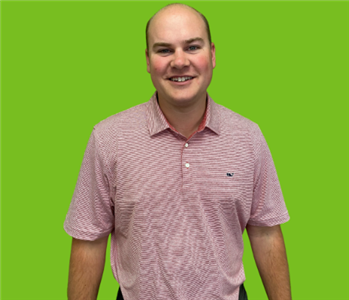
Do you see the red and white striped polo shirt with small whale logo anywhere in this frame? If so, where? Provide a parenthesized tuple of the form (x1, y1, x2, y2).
(64, 93, 289, 300)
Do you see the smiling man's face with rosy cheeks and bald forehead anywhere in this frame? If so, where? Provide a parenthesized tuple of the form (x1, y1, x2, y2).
(146, 7, 216, 106)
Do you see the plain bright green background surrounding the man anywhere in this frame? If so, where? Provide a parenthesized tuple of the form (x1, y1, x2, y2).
(0, 1, 349, 300)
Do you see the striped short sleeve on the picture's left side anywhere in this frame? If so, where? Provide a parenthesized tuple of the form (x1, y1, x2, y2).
(64, 130, 114, 241)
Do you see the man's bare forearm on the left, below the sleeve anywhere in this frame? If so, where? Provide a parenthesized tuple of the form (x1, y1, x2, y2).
(68, 236, 108, 300)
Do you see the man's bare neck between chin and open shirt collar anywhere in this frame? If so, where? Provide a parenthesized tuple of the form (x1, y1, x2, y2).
(158, 94, 206, 138)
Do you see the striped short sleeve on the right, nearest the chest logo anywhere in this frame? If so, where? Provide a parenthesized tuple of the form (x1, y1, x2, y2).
(248, 126, 290, 227)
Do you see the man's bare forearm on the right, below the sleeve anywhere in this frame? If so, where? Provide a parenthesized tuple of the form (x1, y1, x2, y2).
(246, 225, 291, 300)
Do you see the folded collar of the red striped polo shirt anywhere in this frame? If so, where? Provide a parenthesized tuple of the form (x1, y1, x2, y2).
(148, 92, 220, 136)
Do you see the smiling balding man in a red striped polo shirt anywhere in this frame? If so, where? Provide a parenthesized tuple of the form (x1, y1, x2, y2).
(65, 4, 291, 300)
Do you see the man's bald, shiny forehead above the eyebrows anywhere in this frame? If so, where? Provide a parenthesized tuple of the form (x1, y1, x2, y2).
(148, 7, 208, 44)
